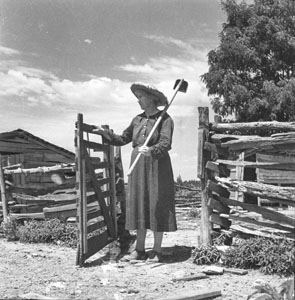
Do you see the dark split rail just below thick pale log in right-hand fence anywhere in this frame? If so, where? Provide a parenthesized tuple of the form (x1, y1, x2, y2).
(212, 195, 295, 227)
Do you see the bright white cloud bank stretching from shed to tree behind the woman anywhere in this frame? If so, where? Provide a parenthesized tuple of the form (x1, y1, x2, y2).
(0, 36, 214, 176)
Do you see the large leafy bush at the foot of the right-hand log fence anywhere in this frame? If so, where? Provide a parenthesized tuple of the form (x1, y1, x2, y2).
(222, 237, 295, 276)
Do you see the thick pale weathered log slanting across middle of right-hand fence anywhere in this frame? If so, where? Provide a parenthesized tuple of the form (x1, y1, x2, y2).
(215, 176, 295, 206)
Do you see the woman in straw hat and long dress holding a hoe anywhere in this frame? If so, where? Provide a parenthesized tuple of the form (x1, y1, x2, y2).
(96, 83, 177, 262)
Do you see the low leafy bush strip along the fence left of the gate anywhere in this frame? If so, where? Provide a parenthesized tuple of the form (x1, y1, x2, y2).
(2, 219, 77, 247)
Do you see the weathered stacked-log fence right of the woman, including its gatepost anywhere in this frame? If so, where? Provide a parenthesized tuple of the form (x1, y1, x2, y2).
(198, 107, 295, 245)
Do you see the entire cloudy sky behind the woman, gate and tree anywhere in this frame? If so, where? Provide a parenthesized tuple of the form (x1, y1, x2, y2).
(0, 0, 226, 180)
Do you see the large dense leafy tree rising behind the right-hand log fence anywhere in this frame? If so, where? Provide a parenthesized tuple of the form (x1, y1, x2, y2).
(201, 0, 295, 122)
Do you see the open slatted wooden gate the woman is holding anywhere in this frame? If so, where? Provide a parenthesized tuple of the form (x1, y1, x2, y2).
(75, 114, 117, 266)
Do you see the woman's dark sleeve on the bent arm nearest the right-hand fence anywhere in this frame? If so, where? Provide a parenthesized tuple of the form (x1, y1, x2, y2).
(151, 117, 174, 159)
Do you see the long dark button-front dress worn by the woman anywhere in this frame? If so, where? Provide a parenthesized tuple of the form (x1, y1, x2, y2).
(104, 112, 177, 232)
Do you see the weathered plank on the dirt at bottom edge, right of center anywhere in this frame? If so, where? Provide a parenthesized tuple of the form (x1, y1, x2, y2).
(158, 288, 221, 300)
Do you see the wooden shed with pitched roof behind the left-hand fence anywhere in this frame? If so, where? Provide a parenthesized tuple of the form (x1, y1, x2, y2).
(0, 129, 75, 192)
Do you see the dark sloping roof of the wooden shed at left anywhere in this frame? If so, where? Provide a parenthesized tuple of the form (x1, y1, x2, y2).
(0, 129, 75, 159)
